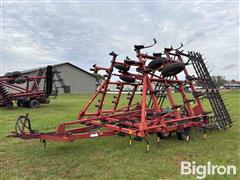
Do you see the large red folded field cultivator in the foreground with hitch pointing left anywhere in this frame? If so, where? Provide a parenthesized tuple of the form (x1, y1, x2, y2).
(12, 40, 232, 149)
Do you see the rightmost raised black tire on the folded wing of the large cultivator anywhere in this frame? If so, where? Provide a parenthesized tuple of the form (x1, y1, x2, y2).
(162, 62, 185, 77)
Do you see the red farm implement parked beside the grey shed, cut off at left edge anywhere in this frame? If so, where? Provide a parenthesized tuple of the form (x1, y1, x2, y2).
(0, 66, 52, 108)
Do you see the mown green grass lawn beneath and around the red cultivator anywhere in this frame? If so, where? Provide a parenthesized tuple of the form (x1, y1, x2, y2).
(0, 91, 240, 179)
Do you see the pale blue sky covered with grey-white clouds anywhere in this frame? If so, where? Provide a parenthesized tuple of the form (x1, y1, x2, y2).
(1, 0, 239, 79)
